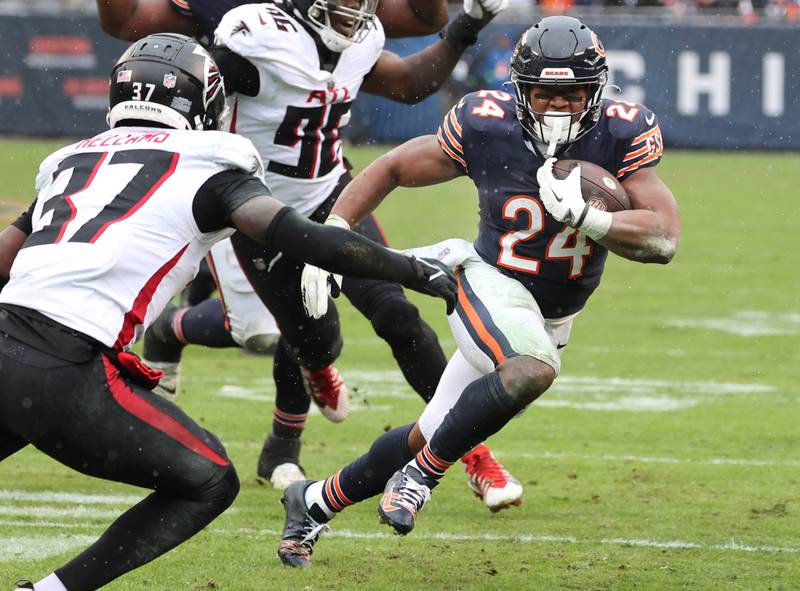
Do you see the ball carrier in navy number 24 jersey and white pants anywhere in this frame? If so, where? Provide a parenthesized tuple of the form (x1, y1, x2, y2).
(278, 16, 680, 566)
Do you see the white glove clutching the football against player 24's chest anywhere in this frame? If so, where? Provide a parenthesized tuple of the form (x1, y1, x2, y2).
(536, 158, 612, 240)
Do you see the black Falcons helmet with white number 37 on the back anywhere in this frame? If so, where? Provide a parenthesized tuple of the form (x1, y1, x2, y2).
(108, 33, 227, 130)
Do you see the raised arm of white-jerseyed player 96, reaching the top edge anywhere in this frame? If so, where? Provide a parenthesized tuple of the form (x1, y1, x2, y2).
(361, 0, 508, 105)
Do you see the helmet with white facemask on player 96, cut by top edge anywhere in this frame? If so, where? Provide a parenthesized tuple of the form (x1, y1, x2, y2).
(284, 0, 378, 53)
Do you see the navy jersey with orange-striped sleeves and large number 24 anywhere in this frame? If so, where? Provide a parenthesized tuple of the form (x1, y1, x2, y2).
(437, 90, 664, 318)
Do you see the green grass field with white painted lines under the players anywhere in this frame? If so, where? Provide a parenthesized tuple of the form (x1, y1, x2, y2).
(0, 141, 800, 591)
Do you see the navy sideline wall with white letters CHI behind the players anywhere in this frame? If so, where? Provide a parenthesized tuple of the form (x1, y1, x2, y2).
(0, 15, 800, 150)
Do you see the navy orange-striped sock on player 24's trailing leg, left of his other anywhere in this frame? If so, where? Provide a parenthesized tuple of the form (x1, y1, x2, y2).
(322, 423, 414, 513)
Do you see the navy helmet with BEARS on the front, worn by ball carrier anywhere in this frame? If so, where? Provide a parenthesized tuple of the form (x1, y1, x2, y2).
(510, 16, 608, 146)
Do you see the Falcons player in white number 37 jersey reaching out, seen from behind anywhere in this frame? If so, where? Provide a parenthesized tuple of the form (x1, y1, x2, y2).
(0, 34, 455, 591)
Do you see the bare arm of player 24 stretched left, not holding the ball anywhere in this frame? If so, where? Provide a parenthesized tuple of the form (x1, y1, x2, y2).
(331, 135, 463, 228)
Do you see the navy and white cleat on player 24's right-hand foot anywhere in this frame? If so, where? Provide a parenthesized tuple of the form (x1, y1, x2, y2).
(378, 465, 439, 536)
